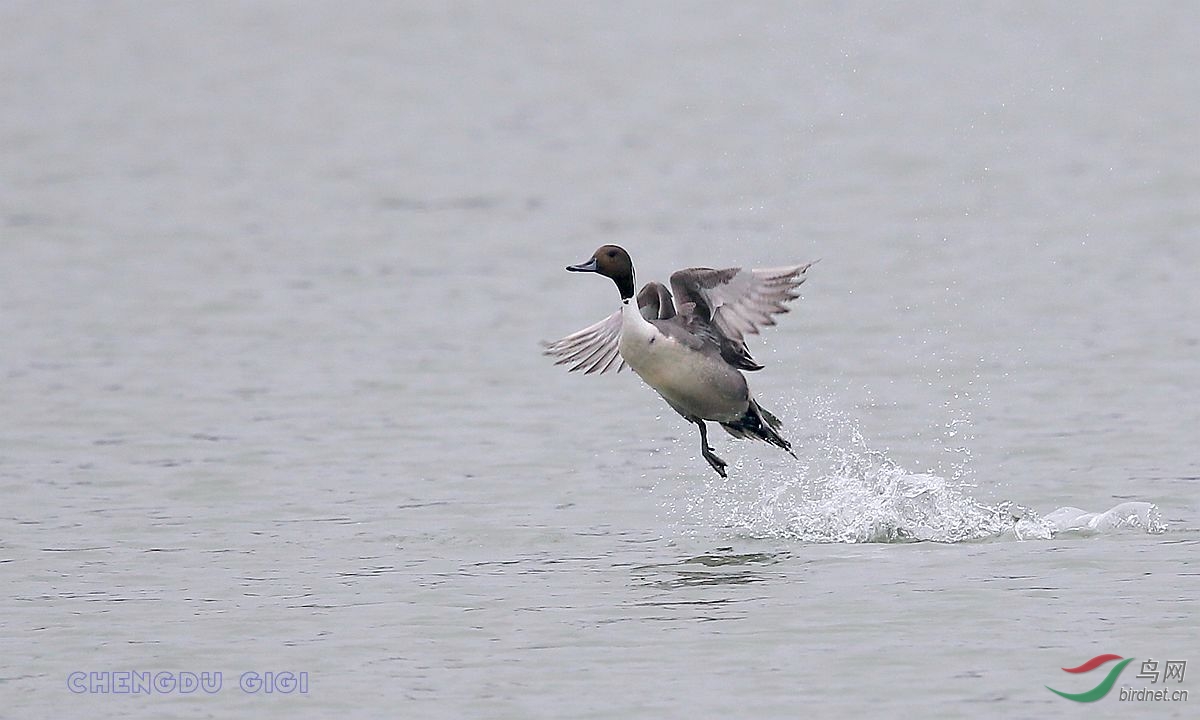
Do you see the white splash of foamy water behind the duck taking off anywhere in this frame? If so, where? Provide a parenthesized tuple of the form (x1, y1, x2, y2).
(665, 397, 1166, 542)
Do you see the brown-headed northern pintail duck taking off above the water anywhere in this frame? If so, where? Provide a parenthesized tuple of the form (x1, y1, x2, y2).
(546, 245, 812, 478)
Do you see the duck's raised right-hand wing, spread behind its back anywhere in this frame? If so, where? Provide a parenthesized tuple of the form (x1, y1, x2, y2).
(671, 263, 812, 343)
